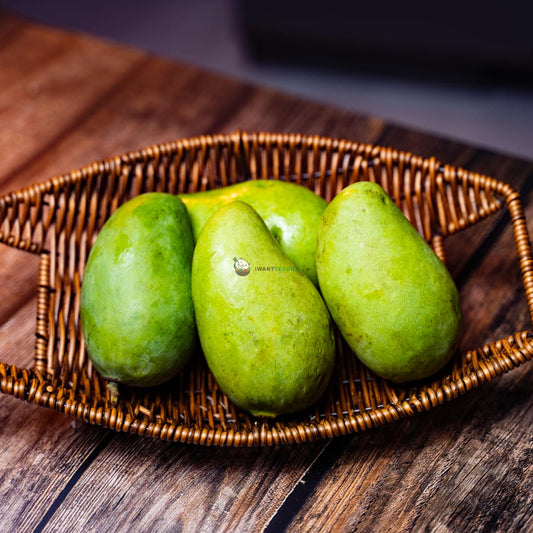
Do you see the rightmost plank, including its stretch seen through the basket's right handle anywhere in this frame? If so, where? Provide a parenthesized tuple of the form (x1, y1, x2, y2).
(276, 156, 533, 531)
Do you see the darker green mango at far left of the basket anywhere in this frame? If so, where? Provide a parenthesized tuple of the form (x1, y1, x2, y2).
(81, 193, 196, 386)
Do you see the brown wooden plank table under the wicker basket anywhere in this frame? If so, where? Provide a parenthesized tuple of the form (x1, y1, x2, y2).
(0, 15, 533, 532)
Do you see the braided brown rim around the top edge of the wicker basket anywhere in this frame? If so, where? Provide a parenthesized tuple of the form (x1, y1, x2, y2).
(0, 130, 533, 446)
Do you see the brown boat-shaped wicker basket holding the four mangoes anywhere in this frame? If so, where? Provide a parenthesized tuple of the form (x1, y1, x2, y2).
(0, 132, 533, 446)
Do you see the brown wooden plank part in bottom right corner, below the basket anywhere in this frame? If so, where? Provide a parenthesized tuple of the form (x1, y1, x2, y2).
(288, 365, 533, 532)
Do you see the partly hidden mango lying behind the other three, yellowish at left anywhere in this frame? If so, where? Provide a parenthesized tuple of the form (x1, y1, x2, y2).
(179, 180, 327, 285)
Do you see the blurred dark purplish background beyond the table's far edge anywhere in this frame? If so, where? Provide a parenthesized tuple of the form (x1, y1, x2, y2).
(0, 0, 533, 159)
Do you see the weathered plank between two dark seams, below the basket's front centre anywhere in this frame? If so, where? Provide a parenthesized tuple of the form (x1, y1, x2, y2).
(38, 435, 323, 533)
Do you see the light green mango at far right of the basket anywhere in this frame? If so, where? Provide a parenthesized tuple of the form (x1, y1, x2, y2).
(317, 182, 461, 383)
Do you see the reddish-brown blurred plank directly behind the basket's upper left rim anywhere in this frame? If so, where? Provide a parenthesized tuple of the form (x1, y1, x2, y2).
(0, 59, 247, 195)
